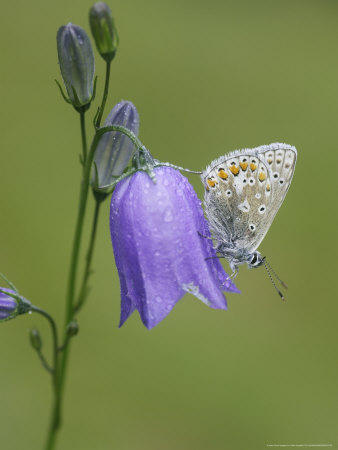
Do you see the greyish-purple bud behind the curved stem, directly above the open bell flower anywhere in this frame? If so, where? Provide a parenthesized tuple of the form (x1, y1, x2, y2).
(94, 100, 139, 188)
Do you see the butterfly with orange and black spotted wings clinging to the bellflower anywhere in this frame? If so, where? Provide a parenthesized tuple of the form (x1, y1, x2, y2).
(201, 143, 297, 298)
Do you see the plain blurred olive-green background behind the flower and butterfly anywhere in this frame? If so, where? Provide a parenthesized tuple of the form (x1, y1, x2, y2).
(0, 0, 338, 450)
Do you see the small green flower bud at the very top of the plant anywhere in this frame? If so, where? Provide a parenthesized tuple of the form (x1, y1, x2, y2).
(89, 2, 118, 62)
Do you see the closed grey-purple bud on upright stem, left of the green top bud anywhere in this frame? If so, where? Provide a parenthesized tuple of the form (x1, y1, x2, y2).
(56, 23, 95, 109)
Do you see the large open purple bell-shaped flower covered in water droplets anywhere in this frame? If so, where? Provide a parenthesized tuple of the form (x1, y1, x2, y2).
(110, 167, 239, 329)
